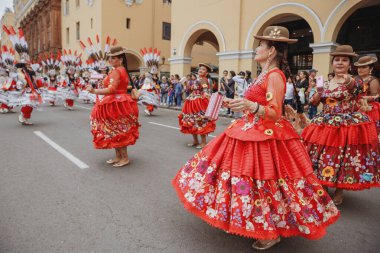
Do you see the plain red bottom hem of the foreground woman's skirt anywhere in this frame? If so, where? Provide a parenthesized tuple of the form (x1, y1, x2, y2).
(172, 178, 340, 240)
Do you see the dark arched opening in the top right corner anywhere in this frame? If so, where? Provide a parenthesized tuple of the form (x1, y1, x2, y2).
(336, 1, 380, 77)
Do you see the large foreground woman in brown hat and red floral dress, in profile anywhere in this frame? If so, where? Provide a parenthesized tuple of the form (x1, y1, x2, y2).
(173, 26, 339, 250)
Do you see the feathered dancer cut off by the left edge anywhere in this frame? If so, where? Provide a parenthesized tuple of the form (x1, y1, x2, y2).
(0, 45, 19, 113)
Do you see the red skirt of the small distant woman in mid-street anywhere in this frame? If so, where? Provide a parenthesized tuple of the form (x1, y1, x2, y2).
(178, 95, 216, 135)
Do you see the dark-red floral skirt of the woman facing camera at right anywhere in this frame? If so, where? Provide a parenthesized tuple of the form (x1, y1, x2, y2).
(302, 112, 380, 190)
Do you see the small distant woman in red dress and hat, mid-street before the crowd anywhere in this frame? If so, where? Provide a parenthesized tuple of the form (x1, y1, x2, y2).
(178, 63, 216, 148)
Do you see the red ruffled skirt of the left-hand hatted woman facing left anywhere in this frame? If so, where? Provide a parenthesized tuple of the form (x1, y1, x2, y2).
(91, 94, 140, 149)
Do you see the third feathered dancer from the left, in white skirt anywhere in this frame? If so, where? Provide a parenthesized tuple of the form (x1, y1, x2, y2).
(41, 52, 62, 106)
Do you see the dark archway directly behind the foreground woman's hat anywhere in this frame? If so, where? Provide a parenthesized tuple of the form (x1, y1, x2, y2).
(253, 14, 314, 74)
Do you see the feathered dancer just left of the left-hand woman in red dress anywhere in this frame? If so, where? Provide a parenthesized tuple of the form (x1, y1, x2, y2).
(59, 50, 82, 111)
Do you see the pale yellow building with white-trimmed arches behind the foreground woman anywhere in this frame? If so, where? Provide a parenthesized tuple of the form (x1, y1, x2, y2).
(169, 0, 380, 77)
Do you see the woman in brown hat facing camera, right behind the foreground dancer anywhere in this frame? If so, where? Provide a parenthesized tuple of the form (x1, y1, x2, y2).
(302, 45, 380, 205)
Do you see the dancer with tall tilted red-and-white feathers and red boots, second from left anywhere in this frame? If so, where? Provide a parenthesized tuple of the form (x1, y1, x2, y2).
(3, 25, 43, 125)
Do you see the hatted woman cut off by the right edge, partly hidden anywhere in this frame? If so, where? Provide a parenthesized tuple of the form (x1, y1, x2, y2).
(354, 55, 380, 140)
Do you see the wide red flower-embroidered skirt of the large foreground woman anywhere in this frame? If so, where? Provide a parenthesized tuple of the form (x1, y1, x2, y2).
(172, 118, 339, 239)
